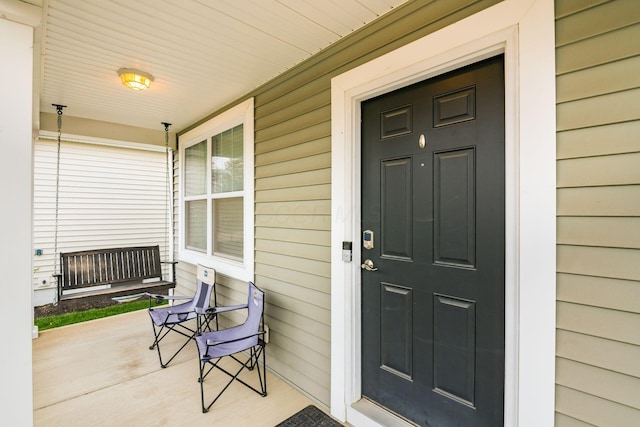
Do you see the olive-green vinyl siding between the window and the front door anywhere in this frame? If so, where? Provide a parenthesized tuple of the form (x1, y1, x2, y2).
(179, 0, 499, 406)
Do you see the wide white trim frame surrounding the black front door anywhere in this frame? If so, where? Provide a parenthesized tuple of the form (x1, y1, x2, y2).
(331, 0, 556, 427)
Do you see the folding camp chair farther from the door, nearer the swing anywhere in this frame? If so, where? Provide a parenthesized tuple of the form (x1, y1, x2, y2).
(146, 265, 217, 368)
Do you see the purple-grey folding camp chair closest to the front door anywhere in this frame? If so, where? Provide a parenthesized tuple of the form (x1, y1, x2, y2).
(196, 282, 267, 412)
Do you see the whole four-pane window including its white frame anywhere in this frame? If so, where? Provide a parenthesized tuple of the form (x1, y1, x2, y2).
(180, 99, 253, 280)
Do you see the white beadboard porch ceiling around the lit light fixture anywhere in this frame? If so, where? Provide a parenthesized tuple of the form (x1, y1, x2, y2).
(32, 0, 406, 132)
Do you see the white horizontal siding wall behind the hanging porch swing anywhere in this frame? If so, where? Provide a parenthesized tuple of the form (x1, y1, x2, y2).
(33, 140, 169, 302)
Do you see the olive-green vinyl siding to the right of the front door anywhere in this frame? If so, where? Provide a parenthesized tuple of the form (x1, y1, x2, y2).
(556, 0, 640, 427)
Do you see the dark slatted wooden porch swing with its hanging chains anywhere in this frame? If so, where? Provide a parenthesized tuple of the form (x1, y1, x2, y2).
(52, 104, 176, 307)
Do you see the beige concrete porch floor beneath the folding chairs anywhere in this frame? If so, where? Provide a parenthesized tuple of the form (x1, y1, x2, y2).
(33, 310, 315, 427)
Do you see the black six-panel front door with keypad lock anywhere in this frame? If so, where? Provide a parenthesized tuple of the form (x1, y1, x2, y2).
(361, 56, 505, 427)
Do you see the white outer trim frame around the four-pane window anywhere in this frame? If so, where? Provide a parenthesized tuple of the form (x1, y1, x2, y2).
(178, 98, 254, 281)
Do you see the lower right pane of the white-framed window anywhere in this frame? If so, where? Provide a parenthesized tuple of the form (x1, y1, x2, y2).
(213, 197, 244, 260)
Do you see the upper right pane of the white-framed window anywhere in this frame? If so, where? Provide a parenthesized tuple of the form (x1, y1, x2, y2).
(211, 125, 244, 193)
